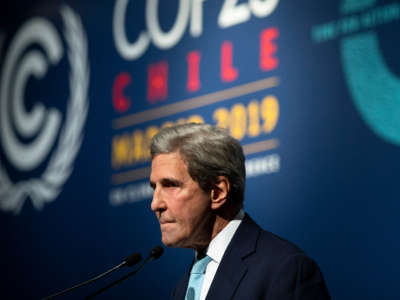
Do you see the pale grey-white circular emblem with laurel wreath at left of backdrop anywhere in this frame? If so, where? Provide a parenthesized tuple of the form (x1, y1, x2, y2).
(0, 6, 89, 214)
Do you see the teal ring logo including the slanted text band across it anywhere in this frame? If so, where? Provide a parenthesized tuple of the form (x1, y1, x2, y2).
(312, 0, 400, 145)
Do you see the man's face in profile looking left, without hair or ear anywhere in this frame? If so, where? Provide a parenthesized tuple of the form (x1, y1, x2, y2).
(150, 152, 212, 249)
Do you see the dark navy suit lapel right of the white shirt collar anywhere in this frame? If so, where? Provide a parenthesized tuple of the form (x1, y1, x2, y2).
(206, 214, 261, 300)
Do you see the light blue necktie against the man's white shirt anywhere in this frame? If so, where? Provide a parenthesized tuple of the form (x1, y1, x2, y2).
(185, 256, 211, 300)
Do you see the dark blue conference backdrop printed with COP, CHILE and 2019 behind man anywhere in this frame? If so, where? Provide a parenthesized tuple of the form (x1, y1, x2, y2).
(0, 0, 400, 299)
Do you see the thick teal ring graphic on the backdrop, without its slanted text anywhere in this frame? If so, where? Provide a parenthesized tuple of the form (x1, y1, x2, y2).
(341, 0, 400, 145)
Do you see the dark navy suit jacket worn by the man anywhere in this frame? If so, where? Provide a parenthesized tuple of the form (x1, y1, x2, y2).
(172, 214, 330, 300)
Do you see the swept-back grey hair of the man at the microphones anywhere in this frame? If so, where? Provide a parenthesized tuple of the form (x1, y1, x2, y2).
(150, 123, 246, 206)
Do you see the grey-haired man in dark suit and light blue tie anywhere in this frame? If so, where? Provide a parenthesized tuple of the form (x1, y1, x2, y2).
(150, 124, 330, 300)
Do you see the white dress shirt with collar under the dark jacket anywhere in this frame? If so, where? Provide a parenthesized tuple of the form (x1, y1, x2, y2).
(196, 209, 244, 300)
